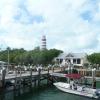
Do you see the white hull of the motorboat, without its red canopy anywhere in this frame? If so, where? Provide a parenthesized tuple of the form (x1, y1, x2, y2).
(54, 82, 100, 98)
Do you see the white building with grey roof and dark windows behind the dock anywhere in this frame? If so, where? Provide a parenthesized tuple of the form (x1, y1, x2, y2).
(55, 53, 88, 66)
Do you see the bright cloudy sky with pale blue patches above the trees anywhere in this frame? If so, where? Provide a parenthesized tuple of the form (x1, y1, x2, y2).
(0, 0, 100, 53)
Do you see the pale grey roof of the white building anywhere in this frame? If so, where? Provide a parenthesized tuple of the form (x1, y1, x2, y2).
(57, 53, 87, 58)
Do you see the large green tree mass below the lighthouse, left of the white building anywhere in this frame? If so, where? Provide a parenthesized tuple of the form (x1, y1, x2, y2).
(0, 47, 63, 65)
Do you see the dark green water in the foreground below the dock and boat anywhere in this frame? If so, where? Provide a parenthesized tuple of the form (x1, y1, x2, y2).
(0, 81, 100, 100)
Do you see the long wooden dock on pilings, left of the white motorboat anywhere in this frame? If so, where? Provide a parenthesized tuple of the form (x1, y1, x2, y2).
(0, 68, 61, 89)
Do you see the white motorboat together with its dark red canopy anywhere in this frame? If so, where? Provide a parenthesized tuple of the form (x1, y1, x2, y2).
(54, 74, 100, 99)
